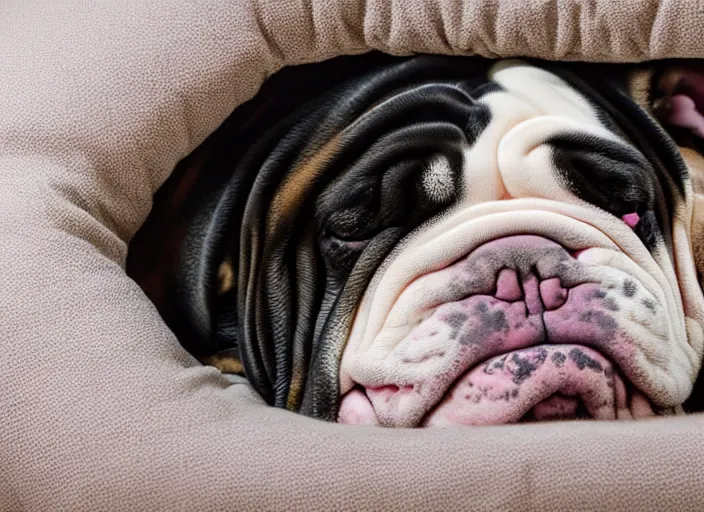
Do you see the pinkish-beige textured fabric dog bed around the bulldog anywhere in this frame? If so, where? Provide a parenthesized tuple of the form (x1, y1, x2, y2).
(0, 0, 704, 510)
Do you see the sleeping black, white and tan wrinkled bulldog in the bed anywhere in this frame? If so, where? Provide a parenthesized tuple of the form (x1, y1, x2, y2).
(128, 54, 704, 427)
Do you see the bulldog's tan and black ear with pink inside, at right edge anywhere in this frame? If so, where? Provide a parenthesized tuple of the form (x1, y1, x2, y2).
(629, 60, 704, 286)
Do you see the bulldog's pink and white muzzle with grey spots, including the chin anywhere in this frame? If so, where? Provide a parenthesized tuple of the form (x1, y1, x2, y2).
(340, 235, 666, 426)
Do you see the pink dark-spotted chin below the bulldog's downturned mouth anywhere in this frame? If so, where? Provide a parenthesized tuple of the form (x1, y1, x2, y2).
(424, 345, 654, 427)
